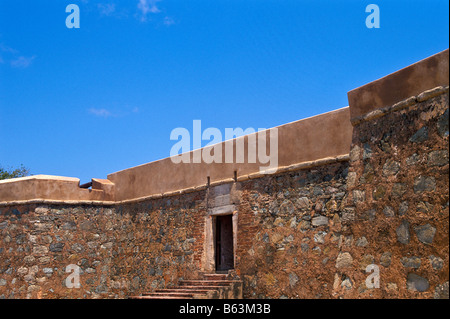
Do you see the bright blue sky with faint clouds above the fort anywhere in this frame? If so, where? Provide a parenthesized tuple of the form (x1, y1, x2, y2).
(0, 0, 449, 183)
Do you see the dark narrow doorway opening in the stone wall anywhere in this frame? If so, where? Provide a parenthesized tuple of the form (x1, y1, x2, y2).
(215, 215, 234, 271)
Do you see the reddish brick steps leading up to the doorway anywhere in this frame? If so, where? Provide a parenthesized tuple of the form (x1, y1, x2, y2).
(129, 273, 242, 299)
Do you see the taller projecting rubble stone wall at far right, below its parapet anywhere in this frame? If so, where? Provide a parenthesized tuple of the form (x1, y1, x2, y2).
(335, 87, 449, 298)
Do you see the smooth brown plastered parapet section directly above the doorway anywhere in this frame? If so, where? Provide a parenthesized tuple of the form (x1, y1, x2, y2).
(108, 107, 352, 201)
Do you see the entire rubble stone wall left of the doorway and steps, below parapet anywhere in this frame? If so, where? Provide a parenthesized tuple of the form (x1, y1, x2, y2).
(0, 192, 205, 298)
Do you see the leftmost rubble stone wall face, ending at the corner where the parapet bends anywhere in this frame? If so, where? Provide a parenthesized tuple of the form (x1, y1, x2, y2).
(0, 205, 121, 298)
